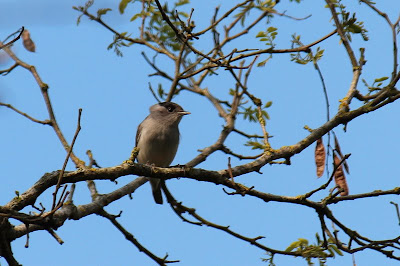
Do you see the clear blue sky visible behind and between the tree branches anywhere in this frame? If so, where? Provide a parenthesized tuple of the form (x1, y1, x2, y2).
(0, 0, 400, 266)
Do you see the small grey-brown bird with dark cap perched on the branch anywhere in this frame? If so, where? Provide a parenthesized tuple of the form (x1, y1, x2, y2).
(136, 102, 190, 204)
